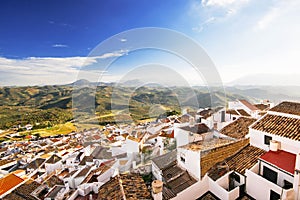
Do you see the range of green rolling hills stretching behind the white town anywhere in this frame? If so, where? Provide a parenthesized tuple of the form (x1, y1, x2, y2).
(0, 80, 300, 129)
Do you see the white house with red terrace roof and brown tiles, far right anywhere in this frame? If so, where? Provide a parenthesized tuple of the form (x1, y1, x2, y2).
(246, 102, 300, 200)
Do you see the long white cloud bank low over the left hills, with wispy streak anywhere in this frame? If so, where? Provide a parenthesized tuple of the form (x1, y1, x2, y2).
(0, 50, 127, 85)
